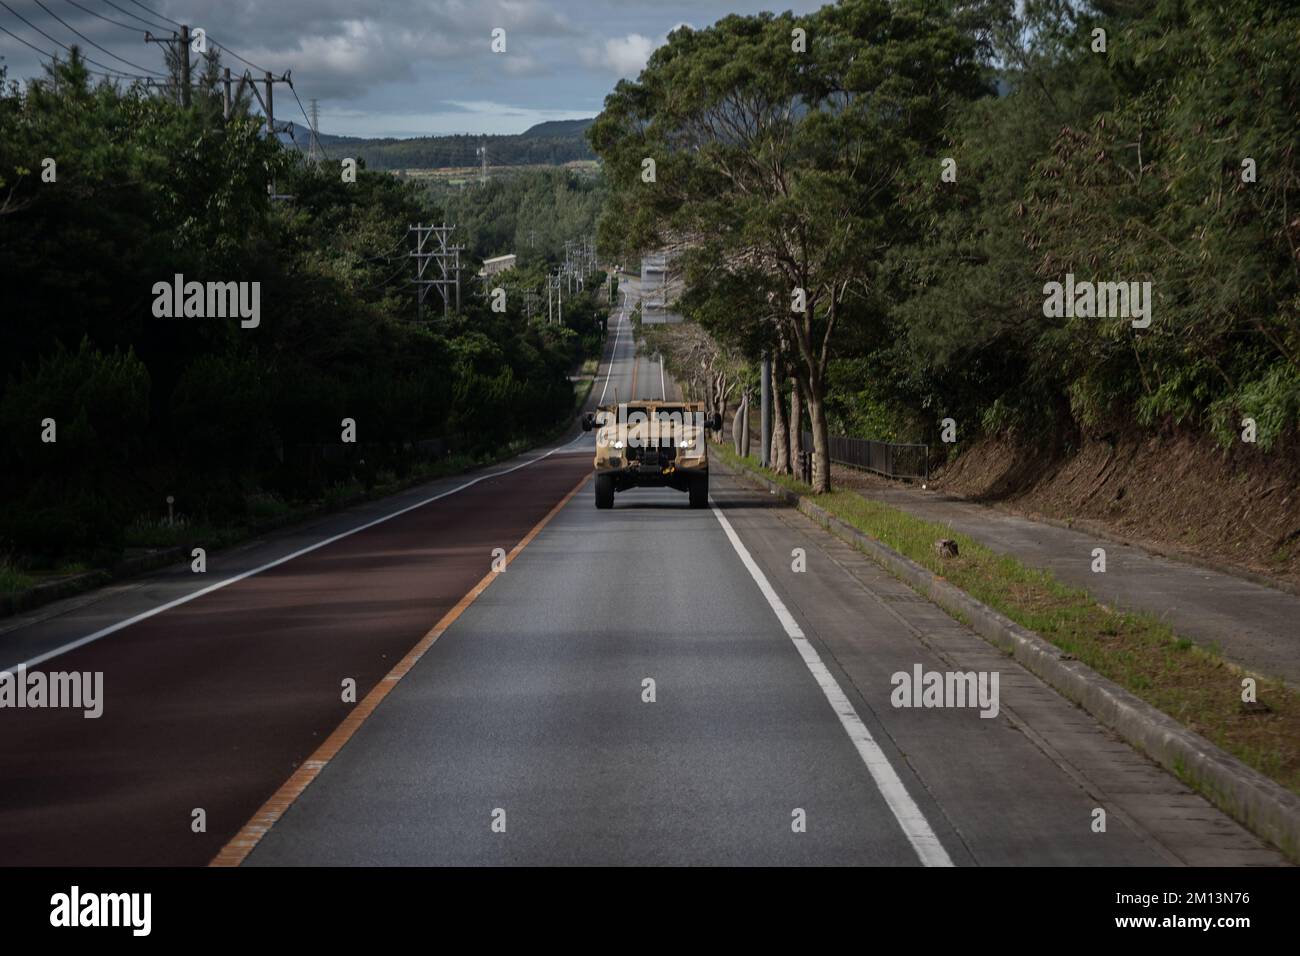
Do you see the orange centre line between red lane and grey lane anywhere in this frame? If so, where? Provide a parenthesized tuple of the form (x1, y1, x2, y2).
(208, 475, 592, 866)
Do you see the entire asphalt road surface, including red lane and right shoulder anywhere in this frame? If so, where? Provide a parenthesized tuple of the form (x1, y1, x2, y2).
(0, 300, 1282, 866)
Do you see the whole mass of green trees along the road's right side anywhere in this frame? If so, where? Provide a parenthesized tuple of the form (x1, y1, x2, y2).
(590, 0, 1300, 489)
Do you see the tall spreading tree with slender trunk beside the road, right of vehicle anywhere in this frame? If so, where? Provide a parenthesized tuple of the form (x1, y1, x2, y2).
(590, 0, 988, 492)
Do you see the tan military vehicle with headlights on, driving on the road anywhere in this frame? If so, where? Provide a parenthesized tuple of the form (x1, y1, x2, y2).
(582, 402, 723, 509)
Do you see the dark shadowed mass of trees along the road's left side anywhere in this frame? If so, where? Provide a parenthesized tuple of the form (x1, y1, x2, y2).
(0, 53, 605, 567)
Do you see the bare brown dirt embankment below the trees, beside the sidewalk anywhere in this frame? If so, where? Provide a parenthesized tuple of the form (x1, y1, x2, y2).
(878, 434, 1300, 587)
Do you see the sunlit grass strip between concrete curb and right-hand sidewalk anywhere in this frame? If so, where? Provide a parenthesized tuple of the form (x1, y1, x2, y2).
(712, 445, 1300, 793)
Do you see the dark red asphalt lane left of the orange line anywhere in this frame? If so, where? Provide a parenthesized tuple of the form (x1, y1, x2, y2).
(0, 454, 592, 866)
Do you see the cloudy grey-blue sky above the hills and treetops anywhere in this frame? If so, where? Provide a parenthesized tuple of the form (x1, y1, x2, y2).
(0, 0, 824, 137)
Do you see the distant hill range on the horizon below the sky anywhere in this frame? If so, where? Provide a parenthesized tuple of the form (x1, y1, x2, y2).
(281, 120, 595, 169)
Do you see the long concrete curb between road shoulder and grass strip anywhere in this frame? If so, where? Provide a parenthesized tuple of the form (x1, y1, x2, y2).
(724, 452, 1300, 862)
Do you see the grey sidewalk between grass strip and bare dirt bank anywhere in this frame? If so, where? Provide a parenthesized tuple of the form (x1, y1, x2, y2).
(854, 485, 1300, 685)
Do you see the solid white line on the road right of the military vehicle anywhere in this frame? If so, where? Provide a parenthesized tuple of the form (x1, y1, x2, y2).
(710, 503, 953, 866)
